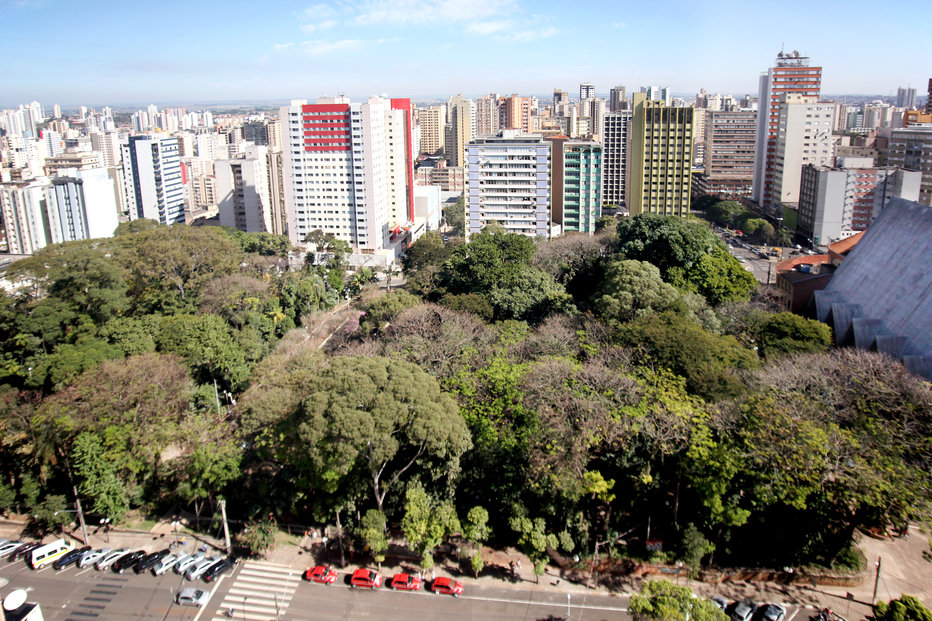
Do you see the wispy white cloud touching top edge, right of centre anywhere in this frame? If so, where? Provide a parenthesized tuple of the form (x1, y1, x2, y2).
(350, 0, 515, 26)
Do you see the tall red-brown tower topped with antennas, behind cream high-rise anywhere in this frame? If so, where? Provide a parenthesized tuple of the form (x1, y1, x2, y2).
(752, 51, 822, 207)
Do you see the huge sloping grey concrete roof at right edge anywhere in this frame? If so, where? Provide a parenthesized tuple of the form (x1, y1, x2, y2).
(822, 198, 932, 366)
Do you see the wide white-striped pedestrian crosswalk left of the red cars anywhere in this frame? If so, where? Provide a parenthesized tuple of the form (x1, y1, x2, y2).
(214, 561, 301, 621)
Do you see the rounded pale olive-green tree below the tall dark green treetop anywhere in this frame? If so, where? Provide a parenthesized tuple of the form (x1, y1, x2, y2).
(593, 260, 679, 323)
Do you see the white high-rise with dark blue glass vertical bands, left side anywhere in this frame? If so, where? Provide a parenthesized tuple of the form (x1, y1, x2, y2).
(121, 136, 185, 224)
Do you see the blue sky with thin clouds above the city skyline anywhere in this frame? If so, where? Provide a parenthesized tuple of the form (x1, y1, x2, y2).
(0, 0, 932, 107)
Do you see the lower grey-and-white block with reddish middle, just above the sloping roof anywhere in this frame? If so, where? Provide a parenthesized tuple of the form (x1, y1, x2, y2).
(796, 158, 920, 245)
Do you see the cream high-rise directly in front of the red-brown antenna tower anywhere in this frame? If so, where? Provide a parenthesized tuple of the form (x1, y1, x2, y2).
(771, 93, 835, 205)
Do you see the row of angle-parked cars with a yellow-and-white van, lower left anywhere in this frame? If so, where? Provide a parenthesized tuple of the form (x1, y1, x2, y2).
(0, 539, 234, 582)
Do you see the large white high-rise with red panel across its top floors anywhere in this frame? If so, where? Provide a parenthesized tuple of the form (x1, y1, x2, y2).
(280, 97, 414, 254)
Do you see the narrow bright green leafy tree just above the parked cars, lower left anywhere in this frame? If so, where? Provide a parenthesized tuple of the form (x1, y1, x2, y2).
(71, 432, 129, 524)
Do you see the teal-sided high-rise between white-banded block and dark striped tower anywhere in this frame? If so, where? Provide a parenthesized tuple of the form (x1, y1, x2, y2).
(546, 136, 602, 234)
